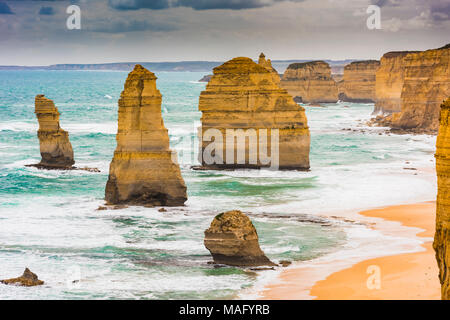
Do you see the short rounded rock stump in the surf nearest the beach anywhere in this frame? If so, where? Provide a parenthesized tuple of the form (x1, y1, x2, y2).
(204, 210, 276, 267)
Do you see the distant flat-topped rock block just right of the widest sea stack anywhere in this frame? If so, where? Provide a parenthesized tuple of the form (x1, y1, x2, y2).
(280, 61, 338, 103)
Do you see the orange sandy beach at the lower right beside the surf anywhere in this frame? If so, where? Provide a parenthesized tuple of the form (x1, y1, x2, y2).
(261, 202, 440, 300)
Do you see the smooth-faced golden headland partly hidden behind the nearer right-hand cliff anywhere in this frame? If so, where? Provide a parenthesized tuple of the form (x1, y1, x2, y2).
(373, 51, 418, 114)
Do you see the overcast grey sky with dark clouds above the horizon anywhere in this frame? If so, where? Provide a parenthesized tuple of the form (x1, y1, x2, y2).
(0, 0, 450, 65)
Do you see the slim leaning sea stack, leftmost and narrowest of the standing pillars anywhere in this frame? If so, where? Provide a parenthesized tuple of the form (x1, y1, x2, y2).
(35, 94, 75, 169)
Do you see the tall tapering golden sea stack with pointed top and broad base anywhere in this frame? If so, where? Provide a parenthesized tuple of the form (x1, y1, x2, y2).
(105, 65, 187, 206)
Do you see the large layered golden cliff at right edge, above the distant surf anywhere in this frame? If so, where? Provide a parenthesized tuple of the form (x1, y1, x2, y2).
(393, 44, 450, 133)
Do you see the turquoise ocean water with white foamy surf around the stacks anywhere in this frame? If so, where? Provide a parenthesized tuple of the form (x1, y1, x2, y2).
(0, 71, 435, 299)
